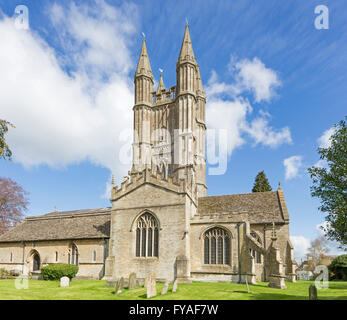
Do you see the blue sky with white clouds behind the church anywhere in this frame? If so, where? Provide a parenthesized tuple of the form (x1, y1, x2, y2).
(0, 0, 347, 257)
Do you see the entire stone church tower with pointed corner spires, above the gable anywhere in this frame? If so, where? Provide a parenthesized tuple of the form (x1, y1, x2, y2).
(131, 25, 207, 197)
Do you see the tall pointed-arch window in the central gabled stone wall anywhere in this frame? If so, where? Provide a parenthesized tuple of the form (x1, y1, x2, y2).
(136, 213, 159, 257)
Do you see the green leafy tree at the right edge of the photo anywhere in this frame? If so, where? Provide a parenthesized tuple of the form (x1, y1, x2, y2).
(308, 117, 347, 250)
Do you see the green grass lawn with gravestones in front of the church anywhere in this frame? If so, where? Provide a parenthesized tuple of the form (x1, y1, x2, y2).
(0, 280, 347, 300)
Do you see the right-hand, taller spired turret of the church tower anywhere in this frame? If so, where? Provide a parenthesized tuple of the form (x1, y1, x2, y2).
(175, 24, 207, 197)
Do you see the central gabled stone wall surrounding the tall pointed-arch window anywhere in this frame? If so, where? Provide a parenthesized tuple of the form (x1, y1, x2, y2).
(106, 183, 196, 281)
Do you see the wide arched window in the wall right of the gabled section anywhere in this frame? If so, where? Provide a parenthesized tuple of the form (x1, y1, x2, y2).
(204, 228, 231, 265)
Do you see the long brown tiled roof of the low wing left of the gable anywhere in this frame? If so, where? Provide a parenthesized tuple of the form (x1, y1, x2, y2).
(0, 208, 111, 242)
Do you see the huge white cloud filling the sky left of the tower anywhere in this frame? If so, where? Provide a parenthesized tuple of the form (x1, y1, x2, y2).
(0, 1, 136, 177)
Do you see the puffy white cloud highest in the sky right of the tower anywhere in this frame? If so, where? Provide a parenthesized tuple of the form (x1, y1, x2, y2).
(235, 57, 281, 102)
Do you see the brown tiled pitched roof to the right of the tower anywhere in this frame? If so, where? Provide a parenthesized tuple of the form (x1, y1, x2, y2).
(198, 191, 289, 223)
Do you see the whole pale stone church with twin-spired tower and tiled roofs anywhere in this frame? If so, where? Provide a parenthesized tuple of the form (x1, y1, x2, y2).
(0, 25, 296, 288)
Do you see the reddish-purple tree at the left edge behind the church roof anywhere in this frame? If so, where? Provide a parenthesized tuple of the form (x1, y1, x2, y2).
(0, 177, 29, 234)
